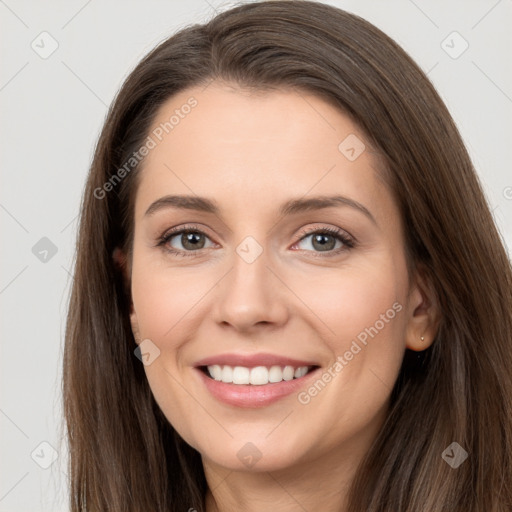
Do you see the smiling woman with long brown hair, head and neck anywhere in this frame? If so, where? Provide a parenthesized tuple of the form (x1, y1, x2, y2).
(63, 1, 512, 512)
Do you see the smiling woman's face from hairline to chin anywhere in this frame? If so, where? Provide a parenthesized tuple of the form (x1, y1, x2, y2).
(126, 82, 427, 471)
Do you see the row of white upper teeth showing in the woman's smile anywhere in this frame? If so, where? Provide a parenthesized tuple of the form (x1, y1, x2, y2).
(207, 364, 308, 386)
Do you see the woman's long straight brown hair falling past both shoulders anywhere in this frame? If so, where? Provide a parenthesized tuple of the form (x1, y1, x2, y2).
(63, 1, 512, 512)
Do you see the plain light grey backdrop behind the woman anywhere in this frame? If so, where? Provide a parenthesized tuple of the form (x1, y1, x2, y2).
(0, 0, 512, 512)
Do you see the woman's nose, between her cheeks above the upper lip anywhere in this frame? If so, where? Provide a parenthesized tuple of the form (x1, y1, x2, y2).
(215, 242, 289, 333)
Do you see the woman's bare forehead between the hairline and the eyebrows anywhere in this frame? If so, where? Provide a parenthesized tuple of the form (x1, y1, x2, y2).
(136, 82, 391, 221)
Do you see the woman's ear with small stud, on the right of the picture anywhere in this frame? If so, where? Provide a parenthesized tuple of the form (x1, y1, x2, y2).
(405, 268, 441, 351)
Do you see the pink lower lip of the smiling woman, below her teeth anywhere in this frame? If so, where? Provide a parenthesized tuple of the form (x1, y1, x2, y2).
(195, 368, 318, 408)
